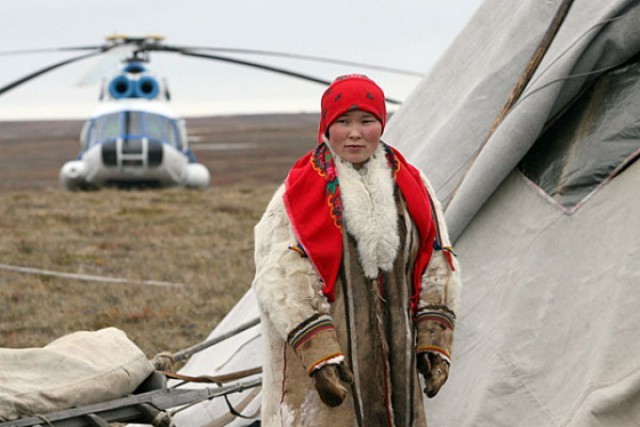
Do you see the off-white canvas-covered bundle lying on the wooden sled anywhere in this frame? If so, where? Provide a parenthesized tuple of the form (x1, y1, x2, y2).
(0, 328, 153, 420)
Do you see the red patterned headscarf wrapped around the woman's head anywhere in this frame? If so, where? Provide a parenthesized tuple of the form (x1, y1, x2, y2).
(318, 74, 387, 142)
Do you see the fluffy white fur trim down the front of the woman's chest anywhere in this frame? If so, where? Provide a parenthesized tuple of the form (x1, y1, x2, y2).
(334, 144, 400, 278)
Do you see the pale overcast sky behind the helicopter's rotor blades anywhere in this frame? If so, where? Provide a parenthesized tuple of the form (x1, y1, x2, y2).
(0, 0, 482, 120)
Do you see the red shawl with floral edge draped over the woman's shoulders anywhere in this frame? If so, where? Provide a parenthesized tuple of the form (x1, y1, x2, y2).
(283, 142, 436, 308)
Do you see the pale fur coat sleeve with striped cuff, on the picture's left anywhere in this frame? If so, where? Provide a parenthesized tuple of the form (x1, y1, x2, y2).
(253, 186, 344, 375)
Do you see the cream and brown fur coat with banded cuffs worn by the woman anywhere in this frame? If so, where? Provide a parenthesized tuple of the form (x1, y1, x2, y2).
(253, 148, 461, 427)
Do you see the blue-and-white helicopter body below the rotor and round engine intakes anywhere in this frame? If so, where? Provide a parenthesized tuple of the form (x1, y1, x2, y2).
(60, 63, 210, 190)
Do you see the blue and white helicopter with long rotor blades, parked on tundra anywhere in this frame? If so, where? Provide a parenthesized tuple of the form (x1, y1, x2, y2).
(0, 34, 422, 190)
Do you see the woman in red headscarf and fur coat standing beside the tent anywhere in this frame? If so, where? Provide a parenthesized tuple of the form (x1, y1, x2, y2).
(253, 75, 461, 426)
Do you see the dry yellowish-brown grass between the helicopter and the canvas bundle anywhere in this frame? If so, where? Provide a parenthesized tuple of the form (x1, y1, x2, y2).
(0, 184, 276, 357)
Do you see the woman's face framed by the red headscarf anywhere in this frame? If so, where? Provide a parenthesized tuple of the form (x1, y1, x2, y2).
(329, 110, 382, 169)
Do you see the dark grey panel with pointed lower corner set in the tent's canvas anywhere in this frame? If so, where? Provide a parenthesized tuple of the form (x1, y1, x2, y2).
(520, 58, 640, 209)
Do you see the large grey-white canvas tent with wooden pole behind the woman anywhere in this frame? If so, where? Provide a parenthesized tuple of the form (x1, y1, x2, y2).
(176, 0, 640, 427)
